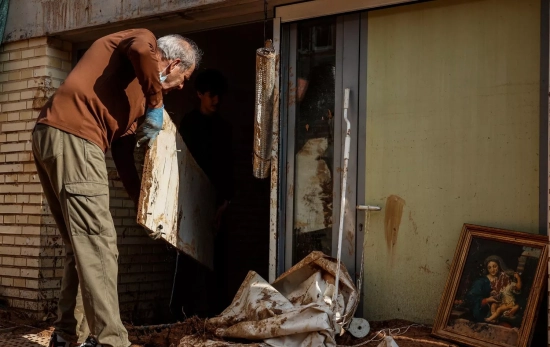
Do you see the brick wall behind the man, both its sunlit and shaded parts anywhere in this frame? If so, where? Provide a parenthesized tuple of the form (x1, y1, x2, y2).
(0, 37, 174, 321)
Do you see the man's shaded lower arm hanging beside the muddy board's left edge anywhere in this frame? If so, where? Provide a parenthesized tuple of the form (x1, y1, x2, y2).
(111, 123, 141, 209)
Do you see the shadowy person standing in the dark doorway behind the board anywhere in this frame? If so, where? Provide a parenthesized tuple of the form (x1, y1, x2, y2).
(174, 69, 234, 319)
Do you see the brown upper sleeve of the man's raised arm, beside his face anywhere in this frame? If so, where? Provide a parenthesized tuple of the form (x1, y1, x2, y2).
(118, 29, 162, 107)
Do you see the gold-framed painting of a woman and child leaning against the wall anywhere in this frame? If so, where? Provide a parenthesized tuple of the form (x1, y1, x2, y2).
(432, 224, 548, 347)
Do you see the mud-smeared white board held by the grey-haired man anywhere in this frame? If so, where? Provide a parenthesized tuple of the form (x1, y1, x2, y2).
(137, 111, 215, 269)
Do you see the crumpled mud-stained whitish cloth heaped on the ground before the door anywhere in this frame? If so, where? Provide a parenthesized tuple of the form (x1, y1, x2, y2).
(179, 252, 359, 347)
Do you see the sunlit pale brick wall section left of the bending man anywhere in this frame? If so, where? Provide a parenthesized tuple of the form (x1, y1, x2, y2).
(0, 38, 71, 317)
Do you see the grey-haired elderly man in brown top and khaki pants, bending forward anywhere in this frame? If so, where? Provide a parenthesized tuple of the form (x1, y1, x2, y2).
(33, 29, 201, 347)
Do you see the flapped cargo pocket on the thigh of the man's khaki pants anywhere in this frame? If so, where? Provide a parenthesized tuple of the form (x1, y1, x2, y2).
(65, 182, 115, 236)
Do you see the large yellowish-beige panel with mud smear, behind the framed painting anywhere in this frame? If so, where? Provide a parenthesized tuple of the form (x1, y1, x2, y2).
(365, 0, 540, 323)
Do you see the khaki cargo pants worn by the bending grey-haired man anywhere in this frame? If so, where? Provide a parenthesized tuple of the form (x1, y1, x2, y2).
(32, 124, 130, 347)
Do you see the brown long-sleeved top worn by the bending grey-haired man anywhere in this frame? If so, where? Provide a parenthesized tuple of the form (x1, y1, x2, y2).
(37, 29, 162, 151)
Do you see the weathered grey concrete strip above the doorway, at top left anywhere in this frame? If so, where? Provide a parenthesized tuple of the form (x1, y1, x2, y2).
(4, 0, 226, 42)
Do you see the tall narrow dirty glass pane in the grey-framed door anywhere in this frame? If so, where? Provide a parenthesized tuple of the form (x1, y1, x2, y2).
(293, 17, 336, 263)
